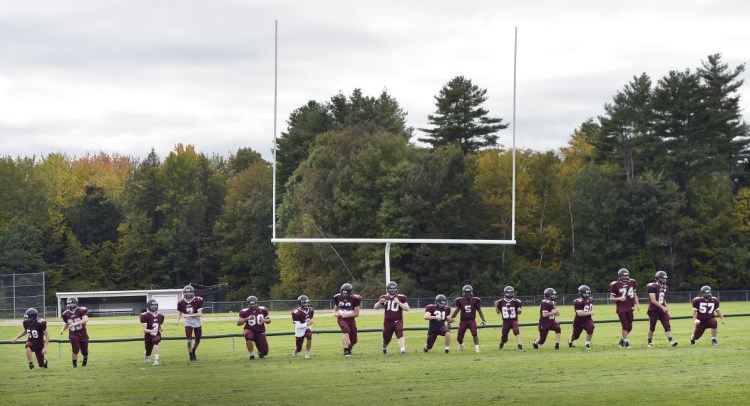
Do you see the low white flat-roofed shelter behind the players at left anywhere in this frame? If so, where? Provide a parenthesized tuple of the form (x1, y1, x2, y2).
(56, 289, 182, 317)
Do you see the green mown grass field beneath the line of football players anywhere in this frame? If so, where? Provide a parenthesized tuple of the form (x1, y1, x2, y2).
(0, 302, 750, 405)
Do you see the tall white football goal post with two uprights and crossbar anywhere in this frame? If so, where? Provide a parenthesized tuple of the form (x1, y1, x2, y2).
(271, 20, 518, 284)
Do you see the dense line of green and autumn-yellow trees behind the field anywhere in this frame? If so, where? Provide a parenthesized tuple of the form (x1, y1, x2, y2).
(0, 54, 750, 300)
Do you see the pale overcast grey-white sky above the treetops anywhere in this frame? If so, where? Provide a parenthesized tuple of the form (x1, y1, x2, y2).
(0, 0, 750, 160)
